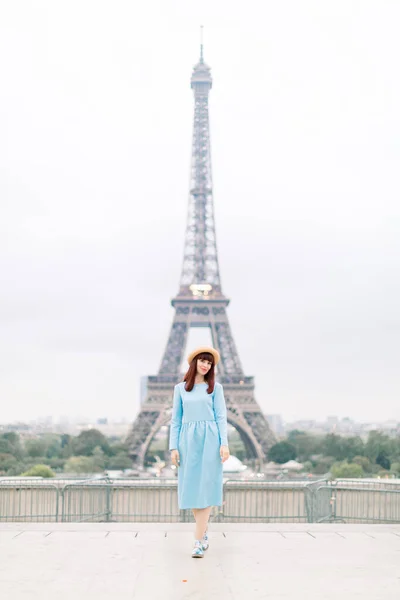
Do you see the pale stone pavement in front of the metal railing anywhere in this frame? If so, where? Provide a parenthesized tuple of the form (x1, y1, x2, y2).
(0, 523, 400, 600)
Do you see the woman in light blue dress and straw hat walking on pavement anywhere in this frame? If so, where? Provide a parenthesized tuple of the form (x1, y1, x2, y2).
(169, 346, 229, 558)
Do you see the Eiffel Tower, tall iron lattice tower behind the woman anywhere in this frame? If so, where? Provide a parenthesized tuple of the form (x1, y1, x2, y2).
(127, 44, 275, 468)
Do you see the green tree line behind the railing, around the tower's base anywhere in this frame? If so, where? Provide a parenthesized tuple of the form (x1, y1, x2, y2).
(0, 429, 400, 478)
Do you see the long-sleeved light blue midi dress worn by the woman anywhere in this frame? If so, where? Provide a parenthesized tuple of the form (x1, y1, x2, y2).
(169, 381, 228, 509)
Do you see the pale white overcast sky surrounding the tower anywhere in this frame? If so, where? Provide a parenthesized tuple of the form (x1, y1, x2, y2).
(0, 0, 400, 422)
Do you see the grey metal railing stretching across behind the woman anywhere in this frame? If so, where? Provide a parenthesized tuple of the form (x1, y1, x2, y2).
(0, 477, 400, 523)
